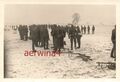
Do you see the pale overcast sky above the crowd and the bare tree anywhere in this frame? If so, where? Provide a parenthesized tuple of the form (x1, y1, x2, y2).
(5, 4, 116, 24)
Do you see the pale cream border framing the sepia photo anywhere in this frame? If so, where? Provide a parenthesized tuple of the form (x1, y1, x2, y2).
(0, 0, 120, 82)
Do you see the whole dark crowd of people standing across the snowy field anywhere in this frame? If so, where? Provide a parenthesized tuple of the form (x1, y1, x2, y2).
(18, 24, 86, 51)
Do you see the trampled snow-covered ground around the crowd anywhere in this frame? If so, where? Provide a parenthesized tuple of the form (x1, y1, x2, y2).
(4, 27, 116, 79)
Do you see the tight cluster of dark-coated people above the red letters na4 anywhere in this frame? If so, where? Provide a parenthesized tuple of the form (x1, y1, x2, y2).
(50, 24, 67, 51)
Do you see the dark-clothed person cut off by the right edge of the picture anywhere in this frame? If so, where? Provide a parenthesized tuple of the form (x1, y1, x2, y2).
(111, 25, 116, 58)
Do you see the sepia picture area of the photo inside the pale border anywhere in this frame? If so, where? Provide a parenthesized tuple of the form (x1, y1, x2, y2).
(4, 4, 116, 79)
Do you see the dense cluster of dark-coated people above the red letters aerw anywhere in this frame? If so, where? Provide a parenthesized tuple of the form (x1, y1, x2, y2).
(29, 24, 49, 51)
